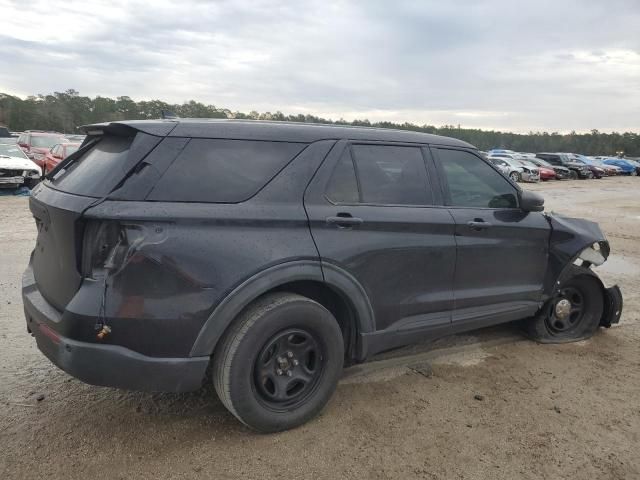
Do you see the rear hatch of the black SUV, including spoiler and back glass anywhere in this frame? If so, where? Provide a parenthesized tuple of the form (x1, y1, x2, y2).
(29, 125, 162, 311)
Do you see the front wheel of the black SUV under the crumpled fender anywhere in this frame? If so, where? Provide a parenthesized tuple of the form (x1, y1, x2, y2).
(524, 267, 604, 343)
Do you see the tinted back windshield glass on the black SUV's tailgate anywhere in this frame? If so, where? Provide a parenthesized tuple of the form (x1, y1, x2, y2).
(51, 135, 133, 197)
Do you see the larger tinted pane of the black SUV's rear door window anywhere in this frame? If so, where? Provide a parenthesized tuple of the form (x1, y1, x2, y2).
(351, 145, 432, 205)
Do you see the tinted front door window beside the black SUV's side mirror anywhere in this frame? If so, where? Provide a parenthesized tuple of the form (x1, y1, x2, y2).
(438, 149, 518, 208)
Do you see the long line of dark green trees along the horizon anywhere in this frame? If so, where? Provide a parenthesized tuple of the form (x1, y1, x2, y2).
(0, 89, 640, 156)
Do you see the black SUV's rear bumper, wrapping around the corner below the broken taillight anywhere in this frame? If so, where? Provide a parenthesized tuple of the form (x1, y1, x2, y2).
(22, 271, 209, 392)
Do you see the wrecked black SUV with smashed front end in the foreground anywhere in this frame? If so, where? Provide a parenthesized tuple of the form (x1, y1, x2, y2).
(23, 120, 622, 432)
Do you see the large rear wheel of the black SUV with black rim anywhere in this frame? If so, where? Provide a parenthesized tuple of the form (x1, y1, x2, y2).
(213, 293, 344, 433)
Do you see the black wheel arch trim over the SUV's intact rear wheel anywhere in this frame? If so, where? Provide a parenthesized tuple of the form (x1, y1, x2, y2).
(190, 260, 375, 362)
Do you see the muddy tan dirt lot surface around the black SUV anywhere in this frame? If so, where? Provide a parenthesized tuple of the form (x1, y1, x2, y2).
(0, 178, 640, 480)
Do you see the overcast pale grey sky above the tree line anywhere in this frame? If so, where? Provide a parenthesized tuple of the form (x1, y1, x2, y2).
(0, 0, 640, 132)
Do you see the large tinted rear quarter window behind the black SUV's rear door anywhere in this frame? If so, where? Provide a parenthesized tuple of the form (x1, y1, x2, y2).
(147, 139, 306, 203)
